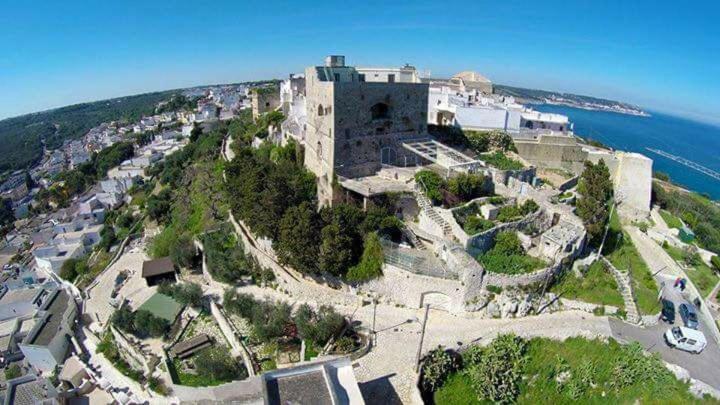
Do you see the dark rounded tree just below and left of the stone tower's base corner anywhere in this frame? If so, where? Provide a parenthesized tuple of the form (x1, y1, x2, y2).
(274, 202, 320, 273)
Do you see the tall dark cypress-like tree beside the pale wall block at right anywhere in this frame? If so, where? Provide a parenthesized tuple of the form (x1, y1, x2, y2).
(576, 159, 613, 246)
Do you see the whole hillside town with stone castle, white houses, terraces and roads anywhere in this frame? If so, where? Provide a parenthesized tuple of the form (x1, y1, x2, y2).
(0, 55, 720, 404)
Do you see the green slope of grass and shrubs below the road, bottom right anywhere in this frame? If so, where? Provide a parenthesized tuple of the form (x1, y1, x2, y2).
(423, 335, 712, 405)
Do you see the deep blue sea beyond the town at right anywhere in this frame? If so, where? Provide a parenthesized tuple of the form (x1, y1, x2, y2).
(531, 104, 720, 200)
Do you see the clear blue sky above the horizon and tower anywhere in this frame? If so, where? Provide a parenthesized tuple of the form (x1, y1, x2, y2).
(0, 0, 720, 124)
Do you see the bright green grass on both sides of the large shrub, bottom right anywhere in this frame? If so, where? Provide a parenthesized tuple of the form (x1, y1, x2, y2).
(433, 338, 711, 405)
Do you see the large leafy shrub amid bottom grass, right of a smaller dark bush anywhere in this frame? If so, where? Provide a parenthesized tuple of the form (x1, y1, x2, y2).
(467, 335, 527, 403)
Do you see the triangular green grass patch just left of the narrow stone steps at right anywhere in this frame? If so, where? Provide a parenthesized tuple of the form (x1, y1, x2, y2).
(550, 261, 625, 309)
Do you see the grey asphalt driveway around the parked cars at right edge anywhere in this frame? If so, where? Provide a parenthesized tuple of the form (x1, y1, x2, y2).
(610, 316, 720, 389)
